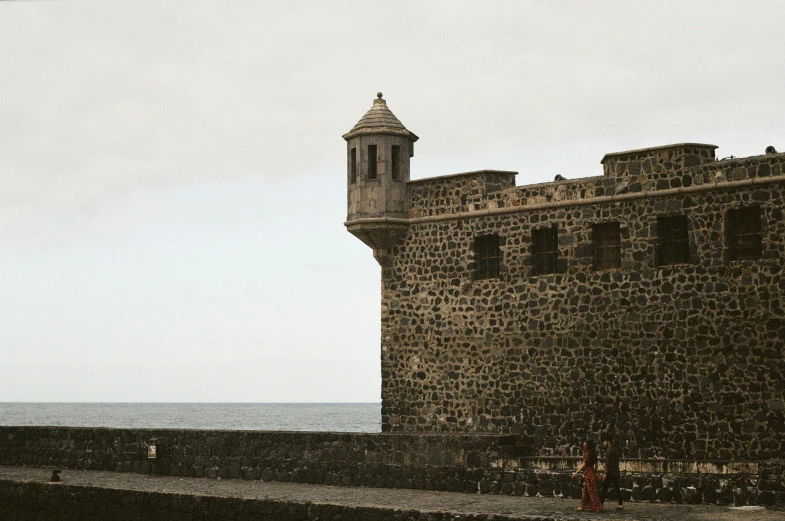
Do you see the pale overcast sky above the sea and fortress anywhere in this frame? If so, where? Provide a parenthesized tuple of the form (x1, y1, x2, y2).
(0, 0, 785, 402)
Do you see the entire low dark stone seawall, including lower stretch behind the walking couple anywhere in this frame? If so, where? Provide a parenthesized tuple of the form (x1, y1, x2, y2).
(0, 427, 785, 506)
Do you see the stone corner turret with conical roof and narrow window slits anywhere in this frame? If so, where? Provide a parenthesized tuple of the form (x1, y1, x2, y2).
(343, 92, 419, 264)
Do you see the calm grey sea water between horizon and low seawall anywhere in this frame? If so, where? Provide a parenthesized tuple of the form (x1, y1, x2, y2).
(0, 402, 381, 432)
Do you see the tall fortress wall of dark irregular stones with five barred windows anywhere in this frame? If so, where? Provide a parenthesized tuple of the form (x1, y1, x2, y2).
(382, 144, 785, 460)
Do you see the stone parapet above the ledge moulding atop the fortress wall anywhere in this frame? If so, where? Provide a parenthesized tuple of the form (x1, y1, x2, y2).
(409, 151, 785, 217)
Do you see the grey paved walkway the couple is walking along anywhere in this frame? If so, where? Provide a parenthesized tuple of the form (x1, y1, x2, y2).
(0, 466, 785, 521)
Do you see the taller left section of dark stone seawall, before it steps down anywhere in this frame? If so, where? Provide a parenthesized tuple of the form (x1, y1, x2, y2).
(0, 427, 515, 492)
